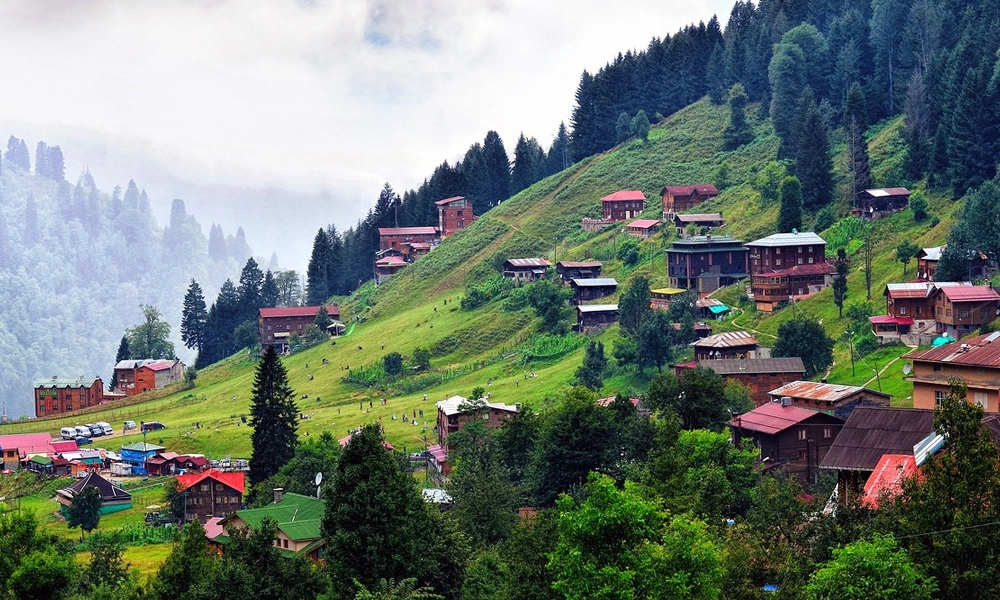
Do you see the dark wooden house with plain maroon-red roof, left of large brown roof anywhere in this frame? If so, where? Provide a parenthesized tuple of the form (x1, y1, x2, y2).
(729, 402, 844, 485)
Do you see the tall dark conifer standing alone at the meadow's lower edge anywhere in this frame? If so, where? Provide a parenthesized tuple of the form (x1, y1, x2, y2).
(250, 346, 298, 486)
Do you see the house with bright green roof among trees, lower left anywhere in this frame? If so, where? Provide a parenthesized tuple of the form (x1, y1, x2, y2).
(212, 488, 324, 561)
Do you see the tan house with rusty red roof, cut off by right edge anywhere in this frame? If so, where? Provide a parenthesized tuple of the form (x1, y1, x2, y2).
(903, 332, 1000, 413)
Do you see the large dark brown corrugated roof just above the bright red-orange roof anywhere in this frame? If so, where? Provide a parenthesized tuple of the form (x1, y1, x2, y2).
(820, 406, 934, 471)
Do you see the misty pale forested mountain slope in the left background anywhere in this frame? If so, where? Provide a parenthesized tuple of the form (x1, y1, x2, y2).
(0, 136, 268, 417)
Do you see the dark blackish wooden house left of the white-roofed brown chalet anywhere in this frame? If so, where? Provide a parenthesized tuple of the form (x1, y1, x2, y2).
(667, 235, 749, 295)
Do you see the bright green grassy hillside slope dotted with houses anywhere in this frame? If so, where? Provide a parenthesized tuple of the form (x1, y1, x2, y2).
(0, 100, 956, 458)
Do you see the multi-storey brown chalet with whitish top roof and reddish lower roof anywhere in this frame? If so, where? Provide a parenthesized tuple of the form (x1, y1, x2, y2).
(747, 232, 836, 312)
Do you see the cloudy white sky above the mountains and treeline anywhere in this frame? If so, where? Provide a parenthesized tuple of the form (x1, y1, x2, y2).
(0, 0, 734, 271)
